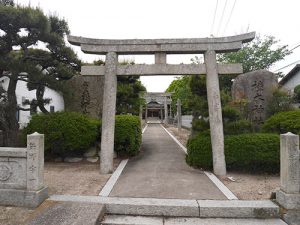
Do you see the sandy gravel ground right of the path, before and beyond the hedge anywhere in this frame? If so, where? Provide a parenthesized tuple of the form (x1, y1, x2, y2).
(166, 125, 280, 200)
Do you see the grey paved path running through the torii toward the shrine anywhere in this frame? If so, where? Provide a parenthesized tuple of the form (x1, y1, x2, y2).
(110, 124, 226, 199)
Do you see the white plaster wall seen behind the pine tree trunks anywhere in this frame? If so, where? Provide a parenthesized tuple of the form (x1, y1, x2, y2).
(2, 78, 65, 128)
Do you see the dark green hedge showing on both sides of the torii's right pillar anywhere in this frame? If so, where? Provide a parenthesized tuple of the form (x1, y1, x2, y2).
(186, 133, 280, 172)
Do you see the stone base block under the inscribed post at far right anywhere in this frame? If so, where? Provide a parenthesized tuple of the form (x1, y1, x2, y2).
(276, 190, 300, 210)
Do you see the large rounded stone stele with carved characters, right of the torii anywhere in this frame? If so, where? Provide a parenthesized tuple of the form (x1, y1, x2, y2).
(232, 70, 278, 127)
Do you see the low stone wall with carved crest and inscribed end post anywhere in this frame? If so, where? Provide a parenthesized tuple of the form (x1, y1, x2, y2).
(0, 133, 48, 207)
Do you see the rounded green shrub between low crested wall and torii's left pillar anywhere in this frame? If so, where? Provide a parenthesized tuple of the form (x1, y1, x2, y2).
(23, 112, 100, 156)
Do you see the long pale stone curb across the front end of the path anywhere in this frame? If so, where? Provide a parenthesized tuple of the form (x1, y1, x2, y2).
(50, 195, 279, 218)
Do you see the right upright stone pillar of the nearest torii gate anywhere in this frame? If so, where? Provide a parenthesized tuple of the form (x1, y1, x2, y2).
(204, 50, 226, 176)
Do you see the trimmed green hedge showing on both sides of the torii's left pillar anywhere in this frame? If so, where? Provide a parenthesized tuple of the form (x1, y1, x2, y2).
(23, 112, 142, 156)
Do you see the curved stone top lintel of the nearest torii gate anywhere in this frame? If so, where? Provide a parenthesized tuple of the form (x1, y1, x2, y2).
(68, 32, 255, 55)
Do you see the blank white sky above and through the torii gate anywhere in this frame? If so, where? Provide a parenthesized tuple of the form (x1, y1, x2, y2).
(15, 0, 300, 92)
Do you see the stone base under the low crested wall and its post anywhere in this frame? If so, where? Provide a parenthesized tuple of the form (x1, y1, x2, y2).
(0, 187, 49, 208)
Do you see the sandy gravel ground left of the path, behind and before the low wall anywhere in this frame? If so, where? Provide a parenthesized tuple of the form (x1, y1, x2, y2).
(0, 159, 120, 225)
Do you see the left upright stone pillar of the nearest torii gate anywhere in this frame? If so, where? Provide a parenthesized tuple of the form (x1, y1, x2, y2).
(100, 52, 118, 174)
